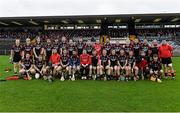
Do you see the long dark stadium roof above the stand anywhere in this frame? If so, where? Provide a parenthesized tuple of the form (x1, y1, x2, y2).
(0, 13, 180, 26)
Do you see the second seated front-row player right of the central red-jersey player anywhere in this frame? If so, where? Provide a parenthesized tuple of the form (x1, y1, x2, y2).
(99, 49, 111, 80)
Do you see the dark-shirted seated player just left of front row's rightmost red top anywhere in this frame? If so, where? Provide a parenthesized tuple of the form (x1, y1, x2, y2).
(126, 51, 139, 81)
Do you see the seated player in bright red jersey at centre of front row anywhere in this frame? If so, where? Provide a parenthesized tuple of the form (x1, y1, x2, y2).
(80, 49, 91, 79)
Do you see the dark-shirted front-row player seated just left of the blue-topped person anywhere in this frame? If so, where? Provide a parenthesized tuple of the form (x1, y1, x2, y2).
(60, 50, 69, 81)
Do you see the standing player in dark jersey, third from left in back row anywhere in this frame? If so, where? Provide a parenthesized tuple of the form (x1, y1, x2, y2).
(33, 37, 44, 59)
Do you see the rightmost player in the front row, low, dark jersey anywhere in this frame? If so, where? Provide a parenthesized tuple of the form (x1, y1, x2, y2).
(149, 54, 163, 82)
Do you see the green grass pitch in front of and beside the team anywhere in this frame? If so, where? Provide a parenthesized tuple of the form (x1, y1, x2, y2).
(0, 56, 180, 112)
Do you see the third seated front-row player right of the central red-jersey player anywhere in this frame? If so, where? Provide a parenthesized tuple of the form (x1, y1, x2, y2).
(109, 49, 118, 79)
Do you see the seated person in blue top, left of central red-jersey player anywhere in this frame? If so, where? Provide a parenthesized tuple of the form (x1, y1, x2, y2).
(69, 51, 80, 81)
